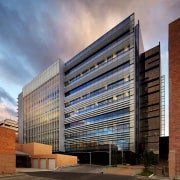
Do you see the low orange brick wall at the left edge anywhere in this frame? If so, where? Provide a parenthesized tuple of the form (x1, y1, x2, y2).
(0, 127, 16, 174)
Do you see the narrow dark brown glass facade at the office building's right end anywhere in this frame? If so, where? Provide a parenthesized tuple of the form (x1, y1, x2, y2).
(139, 45, 161, 154)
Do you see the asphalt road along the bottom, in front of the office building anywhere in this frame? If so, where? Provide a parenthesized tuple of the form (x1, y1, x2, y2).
(0, 165, 158, 180)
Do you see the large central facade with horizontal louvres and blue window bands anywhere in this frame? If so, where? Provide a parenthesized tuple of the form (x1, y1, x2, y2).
(64, 15, 135, 156)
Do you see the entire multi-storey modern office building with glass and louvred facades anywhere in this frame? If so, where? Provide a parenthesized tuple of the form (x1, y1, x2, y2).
(19, 14, 160, 164)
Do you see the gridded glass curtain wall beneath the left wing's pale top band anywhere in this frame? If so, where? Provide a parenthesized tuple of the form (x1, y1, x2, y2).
(23, 75, 59, 150)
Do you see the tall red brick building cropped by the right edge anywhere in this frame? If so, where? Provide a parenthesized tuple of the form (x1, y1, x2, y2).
(169, 18, 180, 178)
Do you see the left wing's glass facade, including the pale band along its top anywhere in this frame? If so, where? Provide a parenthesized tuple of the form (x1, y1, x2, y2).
(23, 61, 64, 151)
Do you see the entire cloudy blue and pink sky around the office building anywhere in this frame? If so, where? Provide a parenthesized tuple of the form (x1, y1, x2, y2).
(0, 0, 180, 135)
